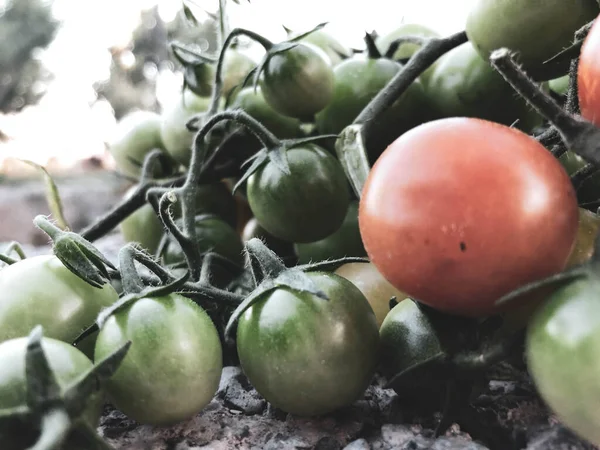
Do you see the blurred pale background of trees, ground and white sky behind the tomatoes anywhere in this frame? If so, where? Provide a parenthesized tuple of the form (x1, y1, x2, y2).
(0, 0, 473, 244)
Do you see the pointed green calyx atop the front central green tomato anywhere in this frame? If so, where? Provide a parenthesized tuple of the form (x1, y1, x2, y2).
(224, 238, 368, 344)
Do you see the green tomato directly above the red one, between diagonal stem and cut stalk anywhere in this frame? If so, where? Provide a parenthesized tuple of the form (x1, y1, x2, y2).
(427, 42, 543, 132)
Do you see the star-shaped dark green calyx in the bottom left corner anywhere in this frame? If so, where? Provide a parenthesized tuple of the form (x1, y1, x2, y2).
(0, 326, 131, 449)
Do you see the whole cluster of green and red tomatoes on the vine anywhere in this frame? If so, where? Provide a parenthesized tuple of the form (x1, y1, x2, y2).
(5, 0, 600, 443)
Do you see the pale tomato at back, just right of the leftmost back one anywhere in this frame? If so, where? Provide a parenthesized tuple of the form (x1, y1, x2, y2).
(160, 89, 210, 166)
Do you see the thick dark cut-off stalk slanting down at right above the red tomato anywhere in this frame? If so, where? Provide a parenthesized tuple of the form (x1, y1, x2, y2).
(490, 48, 600, 165)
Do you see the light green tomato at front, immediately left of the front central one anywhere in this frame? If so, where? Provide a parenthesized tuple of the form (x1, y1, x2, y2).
(95, 294, 222, 425)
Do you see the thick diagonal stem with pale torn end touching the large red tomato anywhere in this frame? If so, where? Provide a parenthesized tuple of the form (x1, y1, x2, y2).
(335, 31, 467, 198)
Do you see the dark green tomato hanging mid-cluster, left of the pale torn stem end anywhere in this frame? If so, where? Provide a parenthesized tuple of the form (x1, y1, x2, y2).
(247, 144, 349, 243)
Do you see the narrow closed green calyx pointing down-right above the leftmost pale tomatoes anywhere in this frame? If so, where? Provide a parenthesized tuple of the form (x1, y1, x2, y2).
(33, 215, 115, 288)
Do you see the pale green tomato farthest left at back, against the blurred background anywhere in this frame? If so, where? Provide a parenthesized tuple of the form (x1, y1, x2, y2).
(108, 111, 165, 178)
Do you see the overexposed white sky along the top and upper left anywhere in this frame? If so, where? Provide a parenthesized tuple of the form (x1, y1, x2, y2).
(0, 0, 475, 171)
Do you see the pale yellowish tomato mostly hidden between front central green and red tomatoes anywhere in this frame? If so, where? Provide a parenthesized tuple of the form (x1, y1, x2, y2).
(334, 263, 407, 327)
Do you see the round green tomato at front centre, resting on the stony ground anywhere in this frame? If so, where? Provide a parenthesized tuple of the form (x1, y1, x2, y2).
(237, 272, 379, 416)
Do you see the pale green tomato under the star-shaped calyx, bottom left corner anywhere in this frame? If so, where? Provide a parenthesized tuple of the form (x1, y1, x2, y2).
(0, 337, 103, 450)
